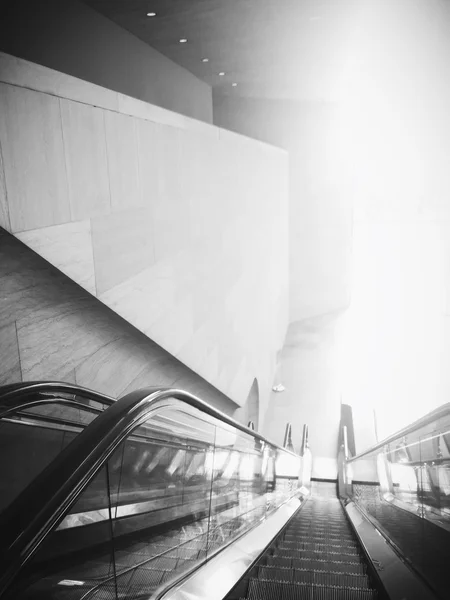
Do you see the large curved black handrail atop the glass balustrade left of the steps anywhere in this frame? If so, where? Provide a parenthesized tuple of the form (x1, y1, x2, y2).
(0, 388, 297, 596)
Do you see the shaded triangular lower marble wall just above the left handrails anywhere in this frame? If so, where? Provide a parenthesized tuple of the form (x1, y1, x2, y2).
(0, 228, 236, 415)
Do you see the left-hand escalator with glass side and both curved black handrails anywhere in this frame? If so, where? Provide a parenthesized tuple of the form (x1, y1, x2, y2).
(0, 384, 300, 600)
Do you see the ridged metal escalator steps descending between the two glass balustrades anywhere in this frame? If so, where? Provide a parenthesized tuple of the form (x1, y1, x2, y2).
(226, 482, 383, 600)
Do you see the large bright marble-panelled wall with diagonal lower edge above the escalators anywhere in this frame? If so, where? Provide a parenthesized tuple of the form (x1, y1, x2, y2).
(0, 54, 288, 426)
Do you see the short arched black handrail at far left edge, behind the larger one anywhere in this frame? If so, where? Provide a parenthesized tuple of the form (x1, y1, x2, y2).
(0, 381, 116, 409)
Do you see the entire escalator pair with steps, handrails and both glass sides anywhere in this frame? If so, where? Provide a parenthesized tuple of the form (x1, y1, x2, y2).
(0, 383, 450, 600)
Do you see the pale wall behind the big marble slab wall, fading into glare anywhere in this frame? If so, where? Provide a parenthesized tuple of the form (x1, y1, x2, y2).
(213, 92, 352, 323)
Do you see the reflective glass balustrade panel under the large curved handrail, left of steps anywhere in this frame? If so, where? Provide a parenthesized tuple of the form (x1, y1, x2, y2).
(7, 401, 299, 600)
